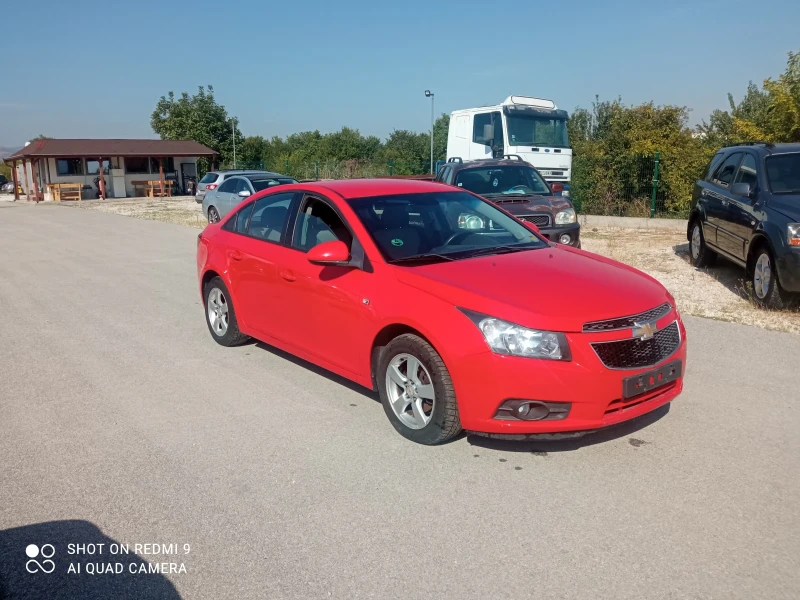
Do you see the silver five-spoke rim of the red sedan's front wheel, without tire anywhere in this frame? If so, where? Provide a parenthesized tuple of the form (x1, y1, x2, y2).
(386, 354, 436, 429)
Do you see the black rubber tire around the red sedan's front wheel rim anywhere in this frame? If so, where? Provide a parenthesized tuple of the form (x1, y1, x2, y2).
(376, 333, 461, 446)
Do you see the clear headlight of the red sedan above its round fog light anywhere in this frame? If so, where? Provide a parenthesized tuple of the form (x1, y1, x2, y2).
(459, 308, 572, 361)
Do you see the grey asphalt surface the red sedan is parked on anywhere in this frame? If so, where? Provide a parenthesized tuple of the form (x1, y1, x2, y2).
(0, 203, 800, 600)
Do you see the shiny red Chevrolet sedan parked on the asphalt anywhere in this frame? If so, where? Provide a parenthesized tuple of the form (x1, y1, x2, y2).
(197, 180, 686, 444)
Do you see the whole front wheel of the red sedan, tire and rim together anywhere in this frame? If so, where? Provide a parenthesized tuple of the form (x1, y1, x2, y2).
(377, 333, 461, 445)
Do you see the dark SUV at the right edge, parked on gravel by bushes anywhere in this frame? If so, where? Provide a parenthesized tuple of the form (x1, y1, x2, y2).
(687, 142, 800, 308)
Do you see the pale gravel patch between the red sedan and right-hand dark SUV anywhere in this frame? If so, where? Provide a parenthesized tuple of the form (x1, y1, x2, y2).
(581, 227, 800, 333)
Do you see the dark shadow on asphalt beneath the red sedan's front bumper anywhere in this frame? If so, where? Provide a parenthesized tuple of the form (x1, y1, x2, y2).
(467, 404, 671, 454)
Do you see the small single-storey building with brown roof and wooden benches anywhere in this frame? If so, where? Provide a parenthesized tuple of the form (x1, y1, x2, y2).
(3, 139, 217, 201)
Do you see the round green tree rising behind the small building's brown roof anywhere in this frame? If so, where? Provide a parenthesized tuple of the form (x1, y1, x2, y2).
(150, 85, 238, 171)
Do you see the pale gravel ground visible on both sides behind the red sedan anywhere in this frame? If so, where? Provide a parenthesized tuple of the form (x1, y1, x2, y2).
(71, 197, 800, 333)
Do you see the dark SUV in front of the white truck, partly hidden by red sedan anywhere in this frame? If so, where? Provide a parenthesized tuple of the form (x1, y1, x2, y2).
(435, 155, 581, 248)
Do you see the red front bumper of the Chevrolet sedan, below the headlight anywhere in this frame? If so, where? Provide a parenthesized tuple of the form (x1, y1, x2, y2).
(448, 311, 686, 435)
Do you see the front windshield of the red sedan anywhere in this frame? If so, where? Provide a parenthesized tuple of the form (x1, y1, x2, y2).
(349, 191, 547, 264)
